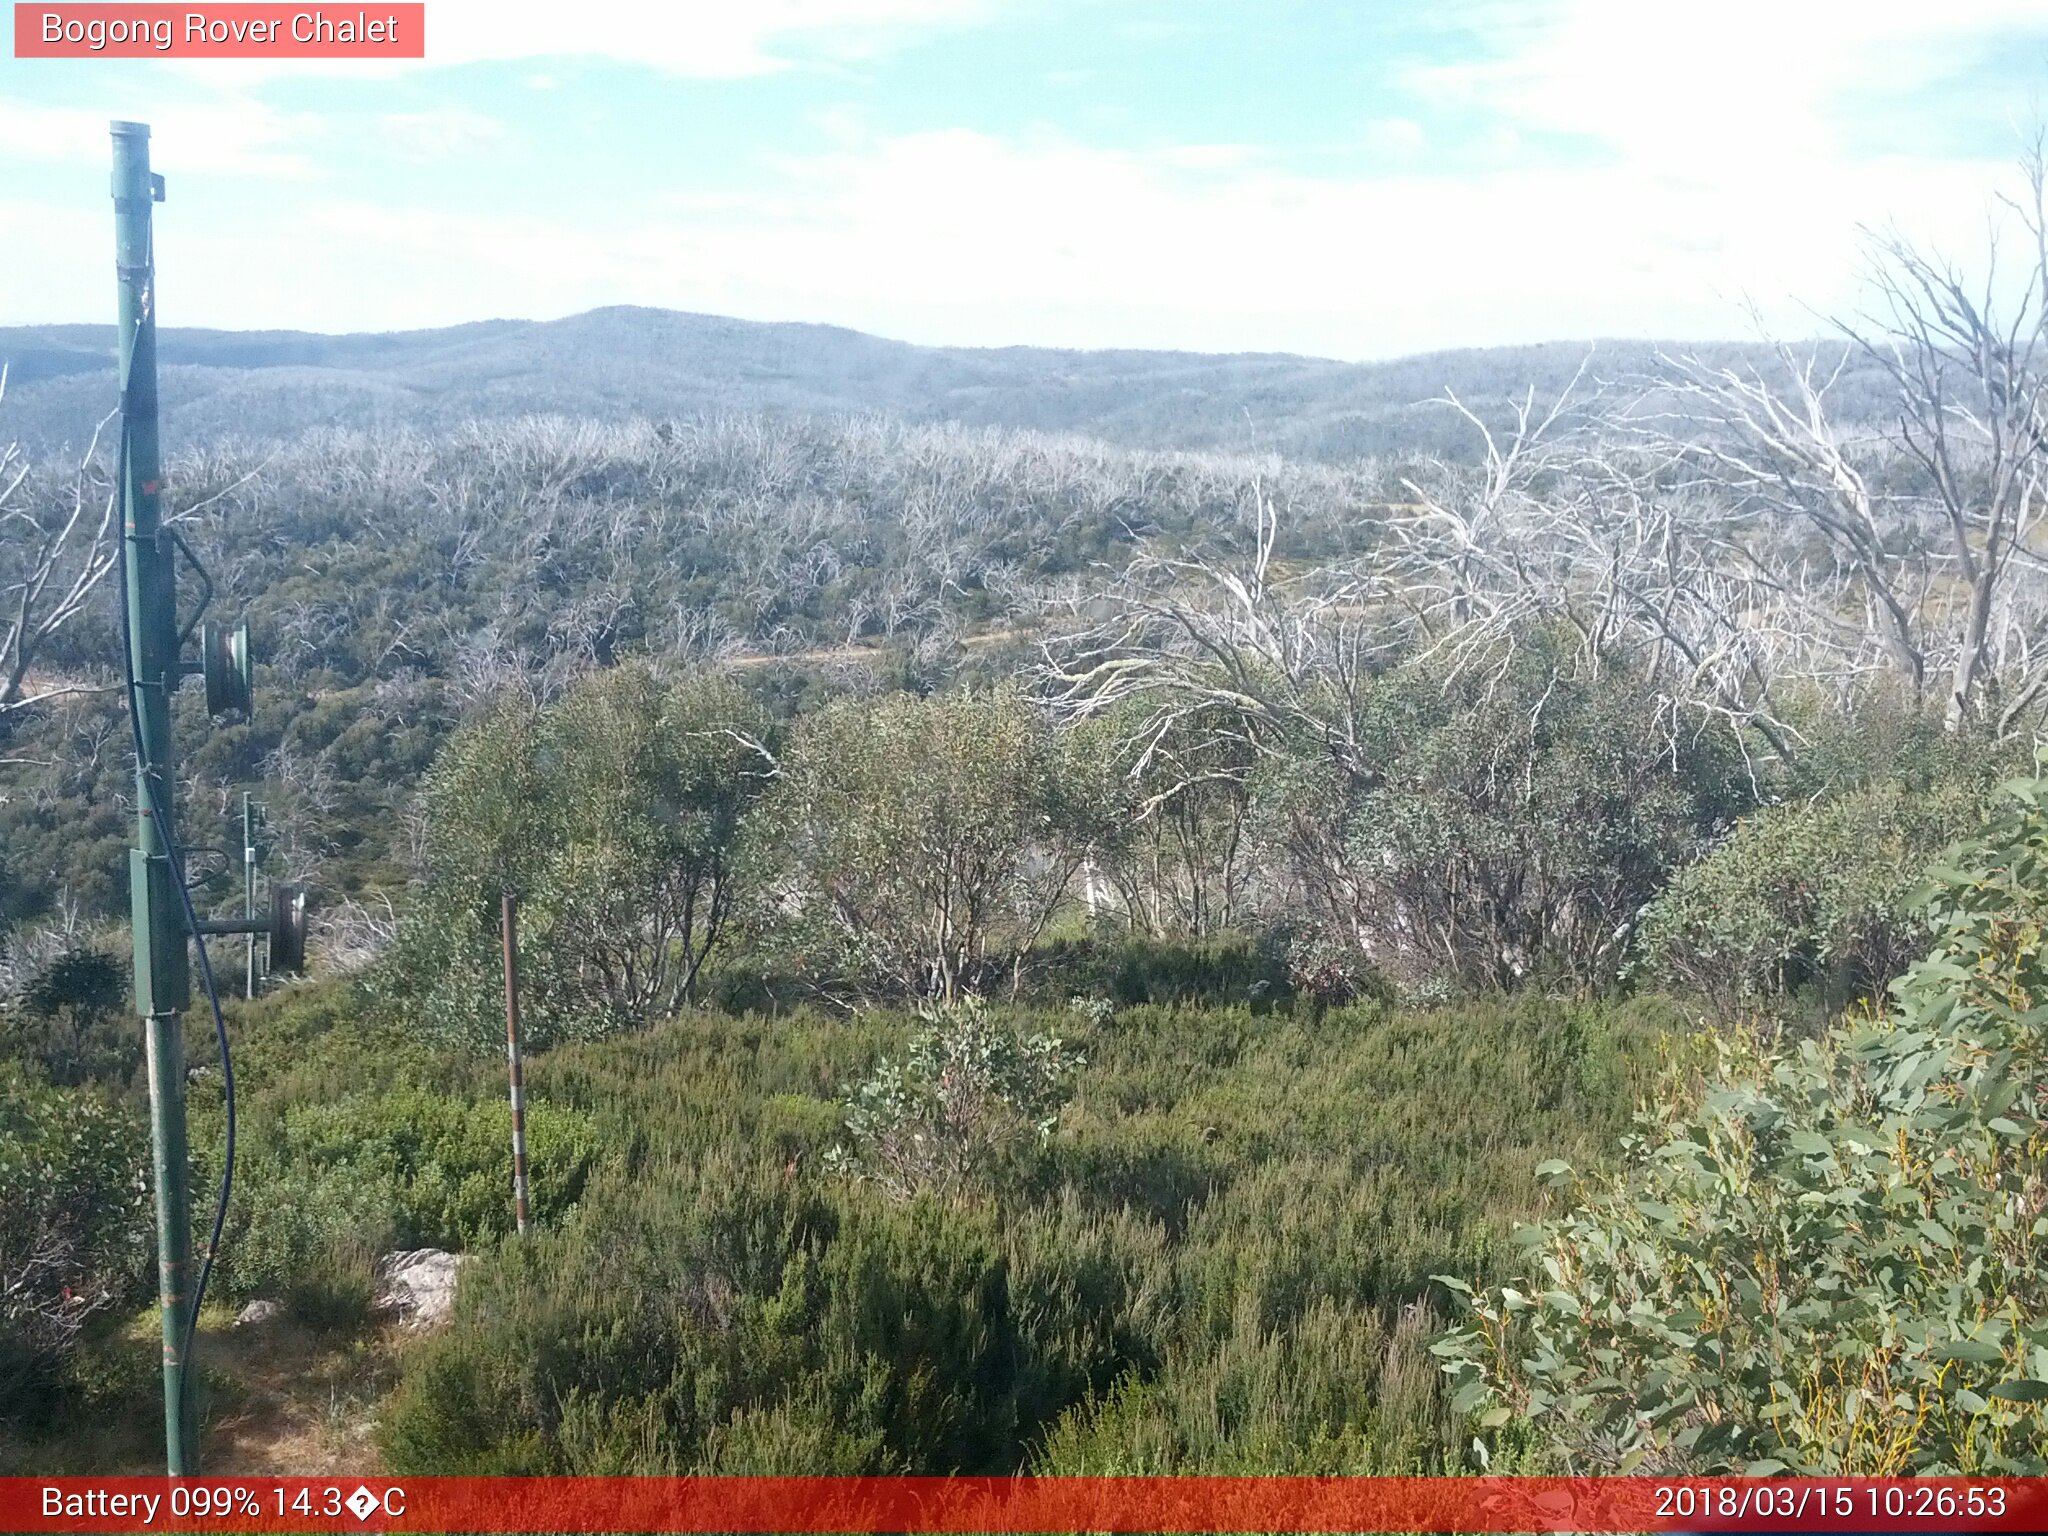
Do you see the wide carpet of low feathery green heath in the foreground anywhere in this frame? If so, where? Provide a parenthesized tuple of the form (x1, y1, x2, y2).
(383, 995, 1675, 1473)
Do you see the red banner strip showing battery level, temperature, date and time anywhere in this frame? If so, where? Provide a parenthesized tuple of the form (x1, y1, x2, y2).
(0, 1477, 2048, 1536)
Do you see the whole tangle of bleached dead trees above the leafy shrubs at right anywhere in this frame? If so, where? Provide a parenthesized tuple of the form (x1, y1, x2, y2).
(1042, 145, 2048, 999)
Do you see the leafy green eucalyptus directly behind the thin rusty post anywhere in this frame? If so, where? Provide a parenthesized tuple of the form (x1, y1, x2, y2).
(383, 664, 774, 1042)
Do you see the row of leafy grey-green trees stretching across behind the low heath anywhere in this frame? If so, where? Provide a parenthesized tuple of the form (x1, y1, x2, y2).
(379, 639, 2017, 1042)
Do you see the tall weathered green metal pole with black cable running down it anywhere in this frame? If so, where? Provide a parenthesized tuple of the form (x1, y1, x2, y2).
(113, 123, 199, 1477)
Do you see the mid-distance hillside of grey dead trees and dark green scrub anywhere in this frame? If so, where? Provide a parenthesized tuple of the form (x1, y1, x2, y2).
(0, 418, 1386, 946)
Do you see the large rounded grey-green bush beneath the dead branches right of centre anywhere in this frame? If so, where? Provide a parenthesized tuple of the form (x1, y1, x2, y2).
(1255, 633, 1753, 999)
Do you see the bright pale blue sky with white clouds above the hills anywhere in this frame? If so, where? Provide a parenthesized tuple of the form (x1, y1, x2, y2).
(0, 0, 2048, 358)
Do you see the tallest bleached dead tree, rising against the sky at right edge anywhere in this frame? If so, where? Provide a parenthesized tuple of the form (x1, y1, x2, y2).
(1618, 141, 2048, 737)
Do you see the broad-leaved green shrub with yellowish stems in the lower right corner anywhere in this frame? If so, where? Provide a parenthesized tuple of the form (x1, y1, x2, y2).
(1436, 780, 2048, 1475)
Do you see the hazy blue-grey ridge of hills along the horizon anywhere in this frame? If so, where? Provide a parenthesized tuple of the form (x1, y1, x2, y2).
(0, 307, 1876, 461)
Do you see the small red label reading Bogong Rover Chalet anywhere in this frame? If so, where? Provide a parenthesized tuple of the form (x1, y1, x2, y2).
(14, 0, 426, 59)
